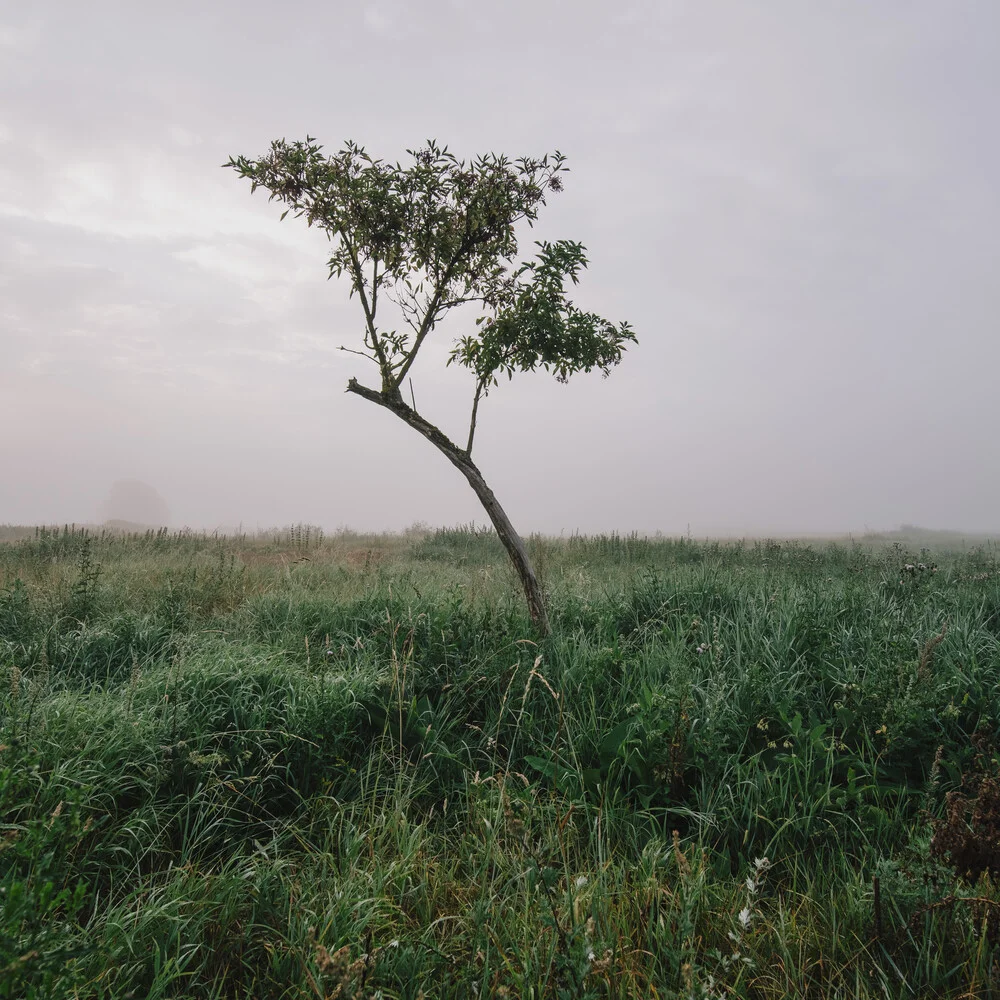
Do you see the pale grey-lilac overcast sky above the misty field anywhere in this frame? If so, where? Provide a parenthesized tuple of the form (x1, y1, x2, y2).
(0, 0, 1000, 535)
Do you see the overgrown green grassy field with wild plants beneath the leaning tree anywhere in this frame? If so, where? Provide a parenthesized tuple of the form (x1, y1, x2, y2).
(0, 529, 1000, 1000)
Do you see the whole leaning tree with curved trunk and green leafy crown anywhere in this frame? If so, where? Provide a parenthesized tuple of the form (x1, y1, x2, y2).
(225, 136, 635, 634)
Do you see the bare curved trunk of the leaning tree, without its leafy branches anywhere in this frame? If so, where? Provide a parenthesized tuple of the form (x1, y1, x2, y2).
(347, 378, 550, 636)
